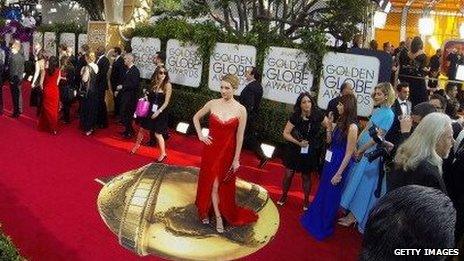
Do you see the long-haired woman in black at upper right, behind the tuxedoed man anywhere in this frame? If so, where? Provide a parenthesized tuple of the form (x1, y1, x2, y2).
(402, 36, 428, 106)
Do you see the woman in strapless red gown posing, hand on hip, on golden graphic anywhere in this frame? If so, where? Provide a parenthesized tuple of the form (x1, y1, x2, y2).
(193, 74, 258, 233)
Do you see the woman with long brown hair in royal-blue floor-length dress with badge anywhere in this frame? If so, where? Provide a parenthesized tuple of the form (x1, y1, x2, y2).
(301, 94, 358, 240)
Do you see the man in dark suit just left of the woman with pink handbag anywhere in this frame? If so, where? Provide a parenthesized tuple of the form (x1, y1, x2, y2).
(115, 53, 140, 139)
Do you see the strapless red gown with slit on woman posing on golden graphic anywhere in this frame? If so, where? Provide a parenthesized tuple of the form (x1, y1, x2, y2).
(195, 114, 258, 226)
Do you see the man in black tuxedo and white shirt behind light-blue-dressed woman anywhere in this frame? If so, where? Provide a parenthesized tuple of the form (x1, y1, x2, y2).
(385, 82, 412, 145)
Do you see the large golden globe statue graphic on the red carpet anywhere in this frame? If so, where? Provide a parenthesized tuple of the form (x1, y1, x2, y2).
(97, 164, 279, 260)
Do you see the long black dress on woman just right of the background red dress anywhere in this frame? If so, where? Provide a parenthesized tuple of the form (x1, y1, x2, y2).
(80, 66, 98, 132)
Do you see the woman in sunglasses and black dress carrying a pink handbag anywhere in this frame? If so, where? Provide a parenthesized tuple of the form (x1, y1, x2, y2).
(131, 65, 172, 162)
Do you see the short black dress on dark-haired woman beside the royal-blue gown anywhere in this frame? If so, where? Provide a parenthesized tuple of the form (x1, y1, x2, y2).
(283, 112, 322, 174)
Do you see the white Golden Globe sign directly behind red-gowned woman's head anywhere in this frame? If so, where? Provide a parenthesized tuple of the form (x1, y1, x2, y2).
(208, 43, 256, 95)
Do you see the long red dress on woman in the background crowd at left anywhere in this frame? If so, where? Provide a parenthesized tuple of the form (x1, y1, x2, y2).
(38, 69, 60, 132)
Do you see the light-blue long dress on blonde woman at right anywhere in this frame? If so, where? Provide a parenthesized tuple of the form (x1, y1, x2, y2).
(340, 107, 395, 233)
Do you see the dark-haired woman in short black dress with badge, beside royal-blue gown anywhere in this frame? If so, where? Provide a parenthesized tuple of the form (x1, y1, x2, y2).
(277, 92, 323, 210)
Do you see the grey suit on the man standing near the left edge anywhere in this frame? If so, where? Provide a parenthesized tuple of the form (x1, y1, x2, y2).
(9, 53, 25, 116)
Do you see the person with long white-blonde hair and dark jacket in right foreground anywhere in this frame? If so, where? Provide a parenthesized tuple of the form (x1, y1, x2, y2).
(388, 112, 454, 193)
